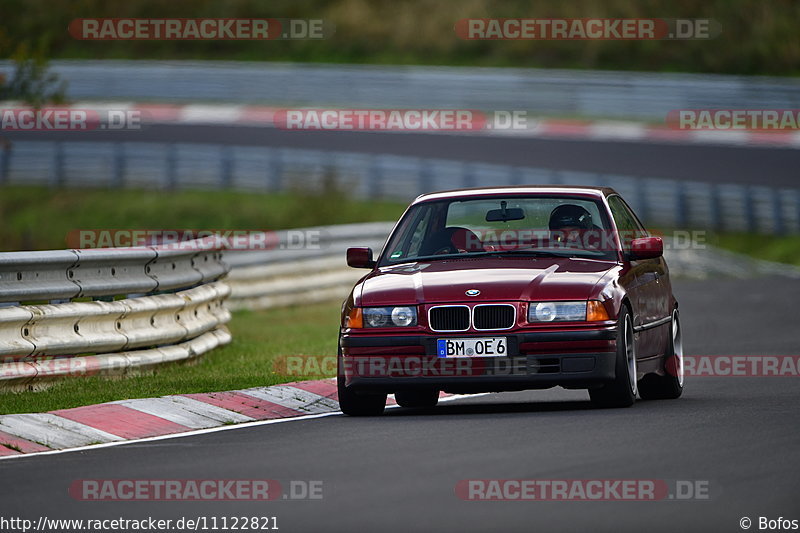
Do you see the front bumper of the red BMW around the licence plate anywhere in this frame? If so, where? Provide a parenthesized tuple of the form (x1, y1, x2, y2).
(339, 327, 616, 393)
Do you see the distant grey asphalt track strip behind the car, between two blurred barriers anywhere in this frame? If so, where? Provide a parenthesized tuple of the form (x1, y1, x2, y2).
(5, 125, 800, 188)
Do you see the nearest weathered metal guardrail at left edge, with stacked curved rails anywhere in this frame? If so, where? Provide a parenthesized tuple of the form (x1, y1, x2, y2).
(0, 240, 230, 390)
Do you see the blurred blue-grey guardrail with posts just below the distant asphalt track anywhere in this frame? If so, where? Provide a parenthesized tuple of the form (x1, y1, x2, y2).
(0, 140, 800, 234)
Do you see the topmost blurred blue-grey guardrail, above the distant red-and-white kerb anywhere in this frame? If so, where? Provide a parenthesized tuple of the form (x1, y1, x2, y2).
(0, 60, 800, 120)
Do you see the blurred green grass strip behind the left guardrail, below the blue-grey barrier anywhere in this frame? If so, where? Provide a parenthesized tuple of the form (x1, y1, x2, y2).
(0, 185, 405, 251)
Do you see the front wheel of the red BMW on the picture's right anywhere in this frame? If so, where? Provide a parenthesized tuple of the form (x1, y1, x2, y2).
(589, 306, 637, 407)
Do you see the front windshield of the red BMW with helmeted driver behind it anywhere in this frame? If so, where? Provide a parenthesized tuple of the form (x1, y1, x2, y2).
(379, 196, 617, 266)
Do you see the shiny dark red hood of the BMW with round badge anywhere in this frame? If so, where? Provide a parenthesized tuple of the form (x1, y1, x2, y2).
(354, 257, 617, 306)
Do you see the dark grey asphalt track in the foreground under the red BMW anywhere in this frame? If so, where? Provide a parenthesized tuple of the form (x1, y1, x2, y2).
(0, 278, 800, 532)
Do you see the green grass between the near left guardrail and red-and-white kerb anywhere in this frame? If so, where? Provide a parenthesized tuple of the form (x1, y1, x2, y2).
(0, 302, 340, 414)
